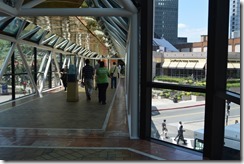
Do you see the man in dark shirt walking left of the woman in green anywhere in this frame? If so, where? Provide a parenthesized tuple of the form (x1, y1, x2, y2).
(81, 59, 94, 100)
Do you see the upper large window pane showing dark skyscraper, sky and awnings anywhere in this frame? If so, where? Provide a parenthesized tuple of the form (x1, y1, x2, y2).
(152, 0, 208, 86)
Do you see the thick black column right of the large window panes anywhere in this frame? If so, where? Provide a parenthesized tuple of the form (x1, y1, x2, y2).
(203, 0, 229, 160)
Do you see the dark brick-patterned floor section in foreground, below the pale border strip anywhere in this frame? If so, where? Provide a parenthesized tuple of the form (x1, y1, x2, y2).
(0, 147, 159, 161)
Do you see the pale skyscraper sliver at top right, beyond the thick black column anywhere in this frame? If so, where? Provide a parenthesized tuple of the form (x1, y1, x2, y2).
(229, 0, 241, 38)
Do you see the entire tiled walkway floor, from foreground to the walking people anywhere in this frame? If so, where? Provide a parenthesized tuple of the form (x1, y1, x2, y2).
(0, 79, 202, 161)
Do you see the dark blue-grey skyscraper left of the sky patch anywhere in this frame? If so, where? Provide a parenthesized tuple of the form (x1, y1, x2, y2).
(154, 0, 178, 44)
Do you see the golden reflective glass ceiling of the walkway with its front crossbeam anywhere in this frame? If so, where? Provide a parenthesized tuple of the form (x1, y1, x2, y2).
(0, 0, 139, 58)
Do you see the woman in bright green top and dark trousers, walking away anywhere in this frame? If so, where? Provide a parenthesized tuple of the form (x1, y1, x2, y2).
(96, 61, 109, 105)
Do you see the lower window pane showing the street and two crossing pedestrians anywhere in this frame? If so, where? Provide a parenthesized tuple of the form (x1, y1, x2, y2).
(151, 88, 205, 149)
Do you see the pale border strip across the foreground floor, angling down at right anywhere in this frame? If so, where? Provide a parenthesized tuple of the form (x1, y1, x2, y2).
(0, 145, 165, 160)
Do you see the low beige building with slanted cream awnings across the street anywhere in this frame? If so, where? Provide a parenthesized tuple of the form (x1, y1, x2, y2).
(153, 35, 240, 83)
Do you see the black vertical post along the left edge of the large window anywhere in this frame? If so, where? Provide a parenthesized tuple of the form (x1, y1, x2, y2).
(139, 0, 154, 139)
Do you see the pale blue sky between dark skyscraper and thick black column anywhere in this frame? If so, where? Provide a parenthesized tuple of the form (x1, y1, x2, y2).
(178, 0, 208, 42)
